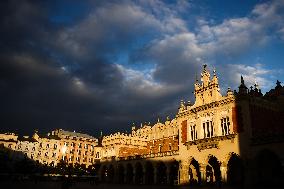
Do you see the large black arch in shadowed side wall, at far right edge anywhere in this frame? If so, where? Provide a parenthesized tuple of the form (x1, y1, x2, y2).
(255, 150, 283, 186)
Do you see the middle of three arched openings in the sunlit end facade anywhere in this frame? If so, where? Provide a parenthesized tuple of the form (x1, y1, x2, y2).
(206, 156, 221, 184)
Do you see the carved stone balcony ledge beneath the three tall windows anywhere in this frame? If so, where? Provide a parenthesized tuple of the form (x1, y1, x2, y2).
(184, 134, 236, 151)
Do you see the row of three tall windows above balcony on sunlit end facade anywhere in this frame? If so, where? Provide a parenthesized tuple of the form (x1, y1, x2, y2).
(189, 117, 231, 140)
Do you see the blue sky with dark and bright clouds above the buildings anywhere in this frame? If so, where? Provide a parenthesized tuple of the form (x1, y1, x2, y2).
(0, 0, 284, 136)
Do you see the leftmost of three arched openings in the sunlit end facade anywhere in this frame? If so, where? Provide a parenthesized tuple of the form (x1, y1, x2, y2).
(188, 159, 201, 185)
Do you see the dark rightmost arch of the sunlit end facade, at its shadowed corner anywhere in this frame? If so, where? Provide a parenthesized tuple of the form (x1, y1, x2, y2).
(227, 154, 244, 186)
